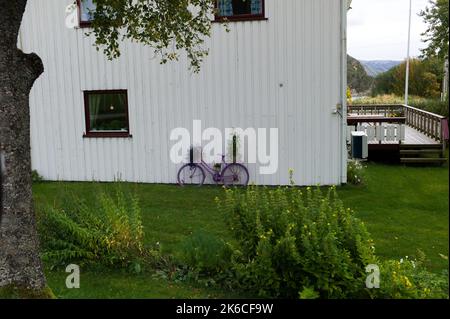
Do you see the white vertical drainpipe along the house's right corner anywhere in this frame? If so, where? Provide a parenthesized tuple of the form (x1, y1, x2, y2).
(339, 0, 352, 184)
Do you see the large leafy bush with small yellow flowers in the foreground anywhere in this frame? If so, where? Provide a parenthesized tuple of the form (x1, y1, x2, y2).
(219, 186, 376, 298)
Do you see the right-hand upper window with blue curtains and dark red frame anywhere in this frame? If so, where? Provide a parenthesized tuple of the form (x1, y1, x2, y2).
(216, 0, 264, 20)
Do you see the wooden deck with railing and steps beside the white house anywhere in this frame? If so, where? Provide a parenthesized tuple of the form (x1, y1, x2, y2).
(347, 105, 448, 163)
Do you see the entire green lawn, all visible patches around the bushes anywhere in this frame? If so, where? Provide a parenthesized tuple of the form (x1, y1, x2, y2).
(34, 164, 449, 298)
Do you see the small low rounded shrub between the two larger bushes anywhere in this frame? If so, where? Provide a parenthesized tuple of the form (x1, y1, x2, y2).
(180, 231, 230, 274)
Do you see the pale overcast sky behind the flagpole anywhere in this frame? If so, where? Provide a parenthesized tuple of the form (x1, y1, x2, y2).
(348, 0, 428, 60)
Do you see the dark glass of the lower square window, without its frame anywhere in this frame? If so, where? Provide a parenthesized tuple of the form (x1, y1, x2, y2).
(89, 93, 128, 132)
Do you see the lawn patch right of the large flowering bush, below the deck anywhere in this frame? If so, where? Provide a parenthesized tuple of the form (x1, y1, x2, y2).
(339, 164, 449, 272)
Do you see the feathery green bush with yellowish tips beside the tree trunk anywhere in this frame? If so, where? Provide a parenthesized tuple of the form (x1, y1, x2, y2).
(38, 190, 146, 271)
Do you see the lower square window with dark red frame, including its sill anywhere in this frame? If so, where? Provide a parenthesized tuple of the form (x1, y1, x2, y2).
(83, 90, 131, 137)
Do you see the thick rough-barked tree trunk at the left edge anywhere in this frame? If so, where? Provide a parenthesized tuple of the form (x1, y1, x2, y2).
(0, 0, 46, 291)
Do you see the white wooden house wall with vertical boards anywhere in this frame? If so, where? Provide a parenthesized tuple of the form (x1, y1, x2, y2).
(18, 0, 348, 185)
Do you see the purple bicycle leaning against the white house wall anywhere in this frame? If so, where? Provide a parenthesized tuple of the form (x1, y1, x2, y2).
(178, 155, 249, 186)
